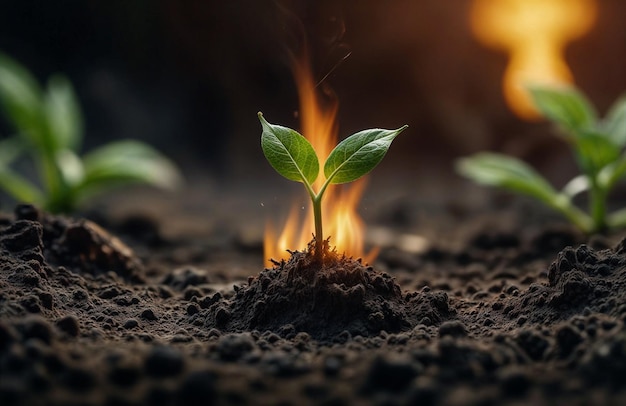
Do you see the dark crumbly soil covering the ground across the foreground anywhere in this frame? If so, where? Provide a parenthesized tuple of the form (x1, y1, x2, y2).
(0, 200, 626, 406)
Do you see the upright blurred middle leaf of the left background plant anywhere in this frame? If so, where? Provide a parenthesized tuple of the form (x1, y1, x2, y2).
(44, 75, 83, 151)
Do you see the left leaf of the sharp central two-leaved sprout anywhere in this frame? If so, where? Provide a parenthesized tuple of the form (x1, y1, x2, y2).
(258, 112, 319, 185)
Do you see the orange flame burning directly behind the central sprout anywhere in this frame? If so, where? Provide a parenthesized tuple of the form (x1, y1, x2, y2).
(264, 57, 376, 262)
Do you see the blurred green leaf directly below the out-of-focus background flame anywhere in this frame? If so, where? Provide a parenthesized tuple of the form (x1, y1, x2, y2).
(528, 86, 597, 137)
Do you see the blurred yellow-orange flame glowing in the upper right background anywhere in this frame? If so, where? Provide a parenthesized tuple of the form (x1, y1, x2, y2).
(471, 0, 596, 120)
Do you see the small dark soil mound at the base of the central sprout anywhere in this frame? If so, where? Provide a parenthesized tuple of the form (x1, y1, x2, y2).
(212, 244, 450, 341)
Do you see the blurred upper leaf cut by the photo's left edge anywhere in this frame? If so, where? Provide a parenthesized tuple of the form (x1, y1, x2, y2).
(0, 53, 45, 145)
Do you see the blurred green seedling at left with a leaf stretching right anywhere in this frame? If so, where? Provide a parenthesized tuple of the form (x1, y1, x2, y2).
(0, 53, 181, 212)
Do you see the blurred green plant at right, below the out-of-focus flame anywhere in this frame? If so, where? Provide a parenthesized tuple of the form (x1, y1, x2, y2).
(456, 87, 626, 233)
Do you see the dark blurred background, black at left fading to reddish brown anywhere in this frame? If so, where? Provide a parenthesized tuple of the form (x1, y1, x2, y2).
(0, 0, 626, 191)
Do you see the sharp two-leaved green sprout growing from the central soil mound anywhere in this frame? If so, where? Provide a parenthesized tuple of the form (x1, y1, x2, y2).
(259, 112, 408, 262)
